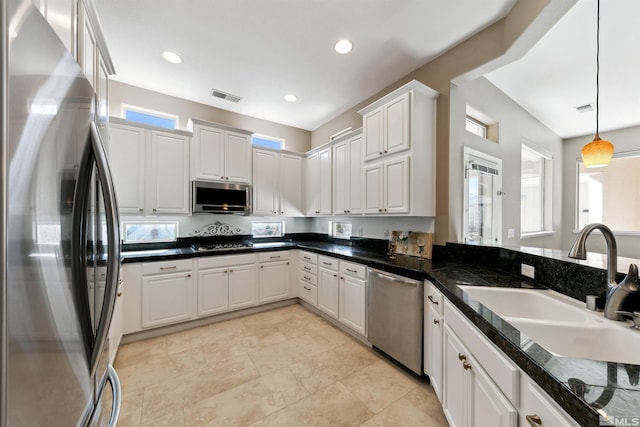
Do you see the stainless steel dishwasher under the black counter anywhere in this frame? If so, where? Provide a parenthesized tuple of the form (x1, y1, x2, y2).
(367, 268, 424, 375)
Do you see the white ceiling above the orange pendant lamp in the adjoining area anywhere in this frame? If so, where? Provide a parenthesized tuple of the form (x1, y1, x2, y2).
(486, 0, 640, 138)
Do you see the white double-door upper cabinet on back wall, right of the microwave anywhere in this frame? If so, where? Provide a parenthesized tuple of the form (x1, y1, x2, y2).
(253, 148, 302, 216)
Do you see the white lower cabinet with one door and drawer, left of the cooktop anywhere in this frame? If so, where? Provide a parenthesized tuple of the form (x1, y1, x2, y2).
(142, 259, 195, 329)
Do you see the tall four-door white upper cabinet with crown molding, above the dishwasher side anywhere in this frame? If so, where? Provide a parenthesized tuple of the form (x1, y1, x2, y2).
(359, 80, 438, 216)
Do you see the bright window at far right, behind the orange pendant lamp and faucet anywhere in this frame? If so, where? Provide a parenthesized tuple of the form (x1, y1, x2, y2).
(576, 151, 640, 233)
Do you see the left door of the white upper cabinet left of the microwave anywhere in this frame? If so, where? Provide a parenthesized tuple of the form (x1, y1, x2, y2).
(109, 124, 146, 214)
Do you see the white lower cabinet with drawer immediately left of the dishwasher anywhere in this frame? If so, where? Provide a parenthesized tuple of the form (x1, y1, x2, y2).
(339, 261, 367, 336)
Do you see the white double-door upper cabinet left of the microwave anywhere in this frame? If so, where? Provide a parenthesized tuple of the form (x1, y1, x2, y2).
(109, 118, 189, 215)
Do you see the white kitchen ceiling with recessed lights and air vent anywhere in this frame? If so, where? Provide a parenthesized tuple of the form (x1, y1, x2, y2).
(96, 0, 520, 130)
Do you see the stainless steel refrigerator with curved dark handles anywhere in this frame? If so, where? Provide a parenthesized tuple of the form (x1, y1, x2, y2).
(0, 0, 120, 427)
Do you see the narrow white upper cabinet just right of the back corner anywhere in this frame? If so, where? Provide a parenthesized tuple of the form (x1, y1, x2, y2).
(306, 147, 332, 216)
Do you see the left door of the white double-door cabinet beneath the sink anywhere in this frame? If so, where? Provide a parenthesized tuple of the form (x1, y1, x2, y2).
(442, 325, 468, 427)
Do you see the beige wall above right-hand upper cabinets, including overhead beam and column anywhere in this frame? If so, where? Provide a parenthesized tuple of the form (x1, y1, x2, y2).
(311, 0, 577, 244)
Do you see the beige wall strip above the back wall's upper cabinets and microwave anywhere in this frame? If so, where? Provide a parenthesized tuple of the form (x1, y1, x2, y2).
(109, 81, 311, 153)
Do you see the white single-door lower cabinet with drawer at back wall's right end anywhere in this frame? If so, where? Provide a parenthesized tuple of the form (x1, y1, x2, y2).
(259, 251, 290, 303)
